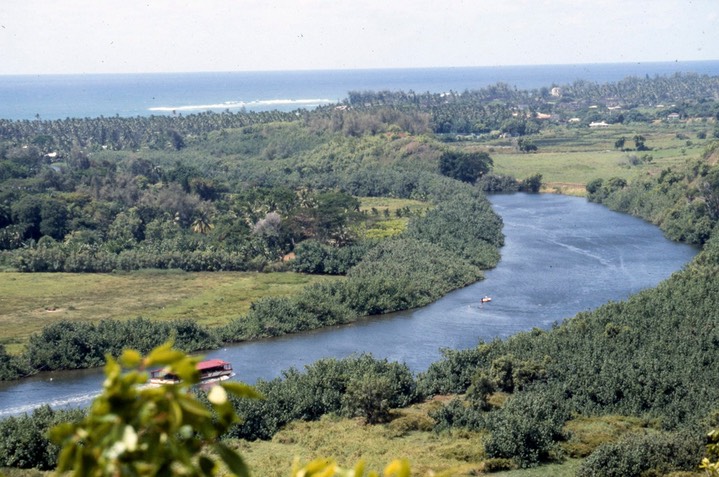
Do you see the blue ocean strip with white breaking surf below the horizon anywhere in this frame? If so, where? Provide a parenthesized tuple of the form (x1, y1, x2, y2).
(0, 61, 719, 120)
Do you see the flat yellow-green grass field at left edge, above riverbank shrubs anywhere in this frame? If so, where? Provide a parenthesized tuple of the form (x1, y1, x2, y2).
(0, 270, 331, 352)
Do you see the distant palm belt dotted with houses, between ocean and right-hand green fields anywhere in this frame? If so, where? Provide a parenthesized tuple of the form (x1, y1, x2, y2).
(347, 73, 719, 136)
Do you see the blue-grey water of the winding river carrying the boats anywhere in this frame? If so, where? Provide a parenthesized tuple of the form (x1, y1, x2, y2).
(0, 194, 697, 417)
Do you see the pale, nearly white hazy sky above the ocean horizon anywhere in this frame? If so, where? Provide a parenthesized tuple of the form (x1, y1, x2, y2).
(0, 0, 719, 75)
